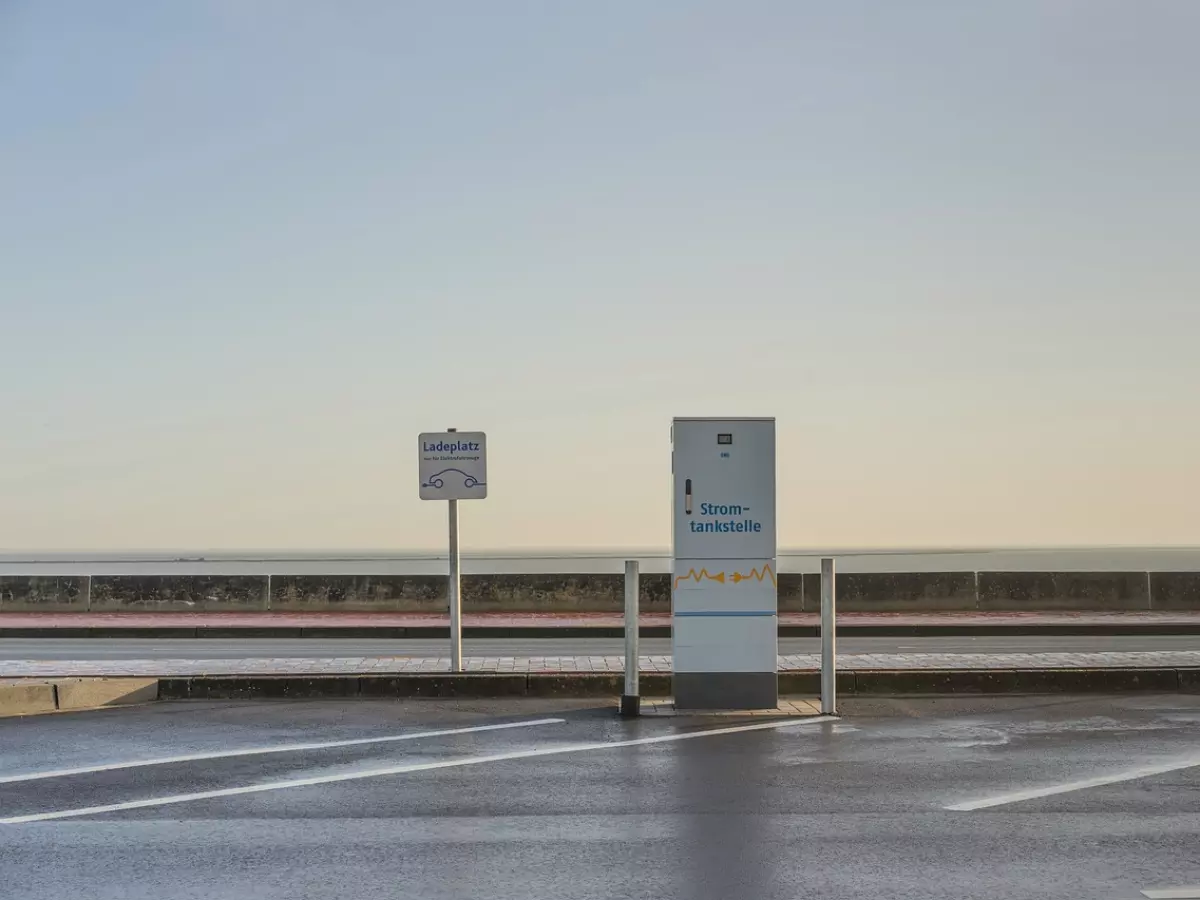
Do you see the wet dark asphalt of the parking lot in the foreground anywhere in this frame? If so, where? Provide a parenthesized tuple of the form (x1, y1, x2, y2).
(0, 695, 1200, 900)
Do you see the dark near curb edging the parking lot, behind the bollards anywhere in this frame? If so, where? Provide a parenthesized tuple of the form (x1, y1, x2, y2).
(158, 668, 1200, 700)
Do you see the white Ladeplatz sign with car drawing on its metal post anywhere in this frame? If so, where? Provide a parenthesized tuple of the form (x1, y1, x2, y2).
(418, 428, 487, 672)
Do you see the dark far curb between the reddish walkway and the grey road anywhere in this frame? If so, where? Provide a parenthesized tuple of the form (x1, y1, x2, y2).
(0, 622, 1200, 641)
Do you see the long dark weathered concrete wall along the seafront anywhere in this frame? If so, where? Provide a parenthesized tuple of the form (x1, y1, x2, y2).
(0, 571, 1200, 614)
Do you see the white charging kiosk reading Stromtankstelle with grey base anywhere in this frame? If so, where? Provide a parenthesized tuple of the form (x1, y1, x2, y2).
(671, 419, 779, 709)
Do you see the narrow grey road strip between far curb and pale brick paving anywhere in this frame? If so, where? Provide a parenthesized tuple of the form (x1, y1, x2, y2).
(0, 635, 1200, 660)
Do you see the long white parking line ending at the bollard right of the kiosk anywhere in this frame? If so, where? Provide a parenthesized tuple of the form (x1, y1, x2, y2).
(0, 715, 836, 824)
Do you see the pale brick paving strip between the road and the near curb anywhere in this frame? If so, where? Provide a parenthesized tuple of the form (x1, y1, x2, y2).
(0, 650, 1200, 678)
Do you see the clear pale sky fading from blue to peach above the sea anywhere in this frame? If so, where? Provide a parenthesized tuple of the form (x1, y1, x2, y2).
(0, 0, 1200, 551)
